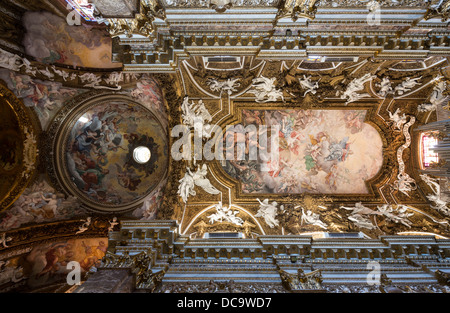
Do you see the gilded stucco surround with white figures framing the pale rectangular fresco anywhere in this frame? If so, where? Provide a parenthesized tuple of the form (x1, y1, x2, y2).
(168, 58, 448, 237)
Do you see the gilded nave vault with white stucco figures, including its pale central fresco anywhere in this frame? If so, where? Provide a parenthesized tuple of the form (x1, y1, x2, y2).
(162, 57, 447, 237)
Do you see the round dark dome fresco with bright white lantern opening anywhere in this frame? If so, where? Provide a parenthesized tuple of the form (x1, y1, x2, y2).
(65, 100, 168, 207)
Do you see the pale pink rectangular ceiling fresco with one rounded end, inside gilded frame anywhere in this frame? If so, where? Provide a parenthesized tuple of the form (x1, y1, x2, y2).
(223, 109, 383, 194)
